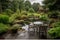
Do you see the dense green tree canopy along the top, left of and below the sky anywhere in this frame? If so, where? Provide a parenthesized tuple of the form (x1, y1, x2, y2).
(0, 0, 40, 12)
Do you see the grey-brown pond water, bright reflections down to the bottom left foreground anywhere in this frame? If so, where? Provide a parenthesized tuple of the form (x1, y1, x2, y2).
(1, 21, 47, 39)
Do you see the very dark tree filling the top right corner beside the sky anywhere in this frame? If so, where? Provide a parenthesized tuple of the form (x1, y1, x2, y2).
(43, 0, 60, 10)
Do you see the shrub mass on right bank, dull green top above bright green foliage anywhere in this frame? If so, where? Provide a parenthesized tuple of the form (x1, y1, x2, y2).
(48, 22, 60, 38)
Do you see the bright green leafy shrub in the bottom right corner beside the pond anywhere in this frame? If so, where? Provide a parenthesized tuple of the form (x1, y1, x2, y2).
(48, 27, 60, 38)
